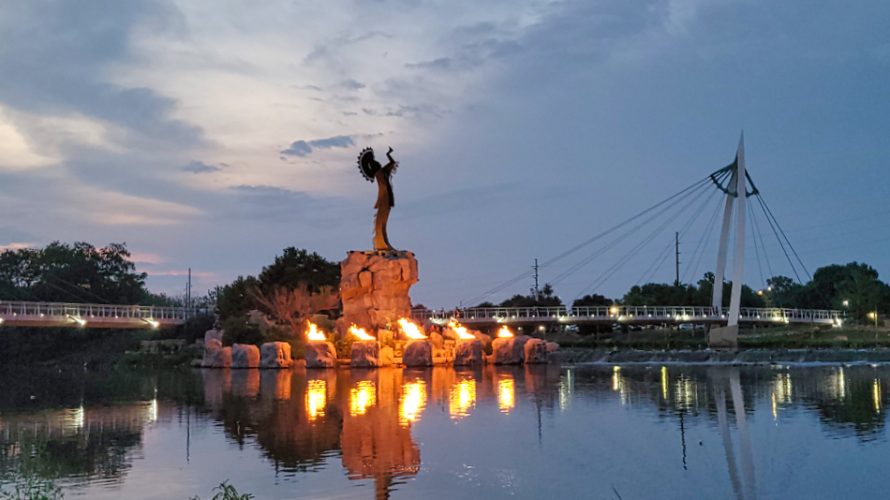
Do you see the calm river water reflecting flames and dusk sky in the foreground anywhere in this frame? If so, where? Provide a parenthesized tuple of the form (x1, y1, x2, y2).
(0, 365, 890, 499)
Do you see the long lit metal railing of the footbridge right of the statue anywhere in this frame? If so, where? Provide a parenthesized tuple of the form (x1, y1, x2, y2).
(412, 305, 843, 324)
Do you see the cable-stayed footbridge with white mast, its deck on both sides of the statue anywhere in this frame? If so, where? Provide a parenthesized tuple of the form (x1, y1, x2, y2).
(0, 138, 843, 347)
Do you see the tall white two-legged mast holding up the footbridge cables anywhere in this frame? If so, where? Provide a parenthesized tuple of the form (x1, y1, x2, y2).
(708, 135, 748, 348)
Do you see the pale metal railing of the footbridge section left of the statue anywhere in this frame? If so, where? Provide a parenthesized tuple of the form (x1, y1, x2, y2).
(0, 301, 203, 321)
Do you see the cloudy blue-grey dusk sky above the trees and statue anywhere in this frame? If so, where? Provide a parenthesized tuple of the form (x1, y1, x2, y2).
(0, 0, 890, 307)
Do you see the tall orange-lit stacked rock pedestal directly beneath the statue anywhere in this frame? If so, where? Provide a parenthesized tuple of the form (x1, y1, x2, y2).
(340, 251, 417, 333)
